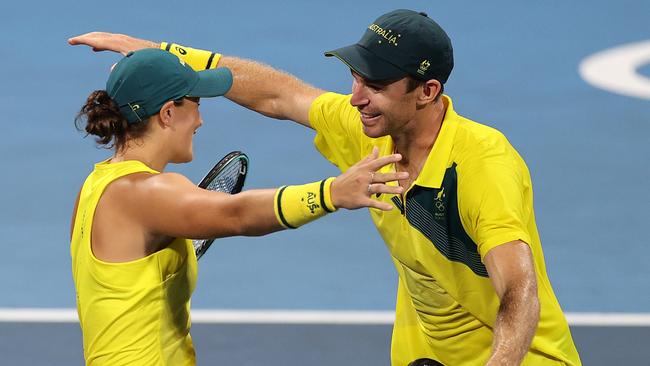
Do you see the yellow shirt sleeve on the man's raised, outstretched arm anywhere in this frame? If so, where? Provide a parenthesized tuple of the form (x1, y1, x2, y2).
(309, 93, 372, 171)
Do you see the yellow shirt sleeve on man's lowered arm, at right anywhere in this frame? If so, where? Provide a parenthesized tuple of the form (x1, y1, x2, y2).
(458, 137, 532, 258)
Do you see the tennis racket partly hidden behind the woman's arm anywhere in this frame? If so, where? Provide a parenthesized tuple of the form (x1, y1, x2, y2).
(193, 151, 248, 259)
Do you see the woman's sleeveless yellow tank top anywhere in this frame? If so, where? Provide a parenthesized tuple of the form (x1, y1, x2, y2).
(70, 161, 197, 365)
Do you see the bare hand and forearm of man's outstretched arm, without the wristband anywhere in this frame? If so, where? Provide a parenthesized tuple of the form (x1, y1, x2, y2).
(68, 32, 325, 127)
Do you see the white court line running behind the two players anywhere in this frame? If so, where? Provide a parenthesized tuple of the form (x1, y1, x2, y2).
(0, 308, 650, 327)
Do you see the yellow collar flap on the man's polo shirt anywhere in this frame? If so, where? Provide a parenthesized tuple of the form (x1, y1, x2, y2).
(414, 95, 459, 188)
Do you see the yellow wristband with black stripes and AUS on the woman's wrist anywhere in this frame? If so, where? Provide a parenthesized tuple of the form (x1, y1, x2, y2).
(275, 178, 336, 229)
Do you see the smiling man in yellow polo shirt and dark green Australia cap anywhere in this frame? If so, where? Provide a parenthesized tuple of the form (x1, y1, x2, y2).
(70, 10, 580, 366)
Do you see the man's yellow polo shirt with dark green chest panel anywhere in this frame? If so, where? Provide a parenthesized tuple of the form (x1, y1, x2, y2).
(309, 93, 580, 366)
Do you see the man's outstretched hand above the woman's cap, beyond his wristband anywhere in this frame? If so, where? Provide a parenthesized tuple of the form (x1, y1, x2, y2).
(68, 32, 160, 56)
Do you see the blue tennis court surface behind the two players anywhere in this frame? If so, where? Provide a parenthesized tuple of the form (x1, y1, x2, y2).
(0, 0, 650, 365)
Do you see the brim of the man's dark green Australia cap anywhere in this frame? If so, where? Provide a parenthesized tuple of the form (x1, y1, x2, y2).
(325, 44, 408, 80)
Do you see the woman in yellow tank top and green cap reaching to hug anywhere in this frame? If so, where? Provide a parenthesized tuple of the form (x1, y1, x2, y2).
(70, 49, 407, 365)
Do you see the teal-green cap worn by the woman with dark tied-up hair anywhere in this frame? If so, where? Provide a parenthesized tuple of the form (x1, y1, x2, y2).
(106, 48, 232, 123)
